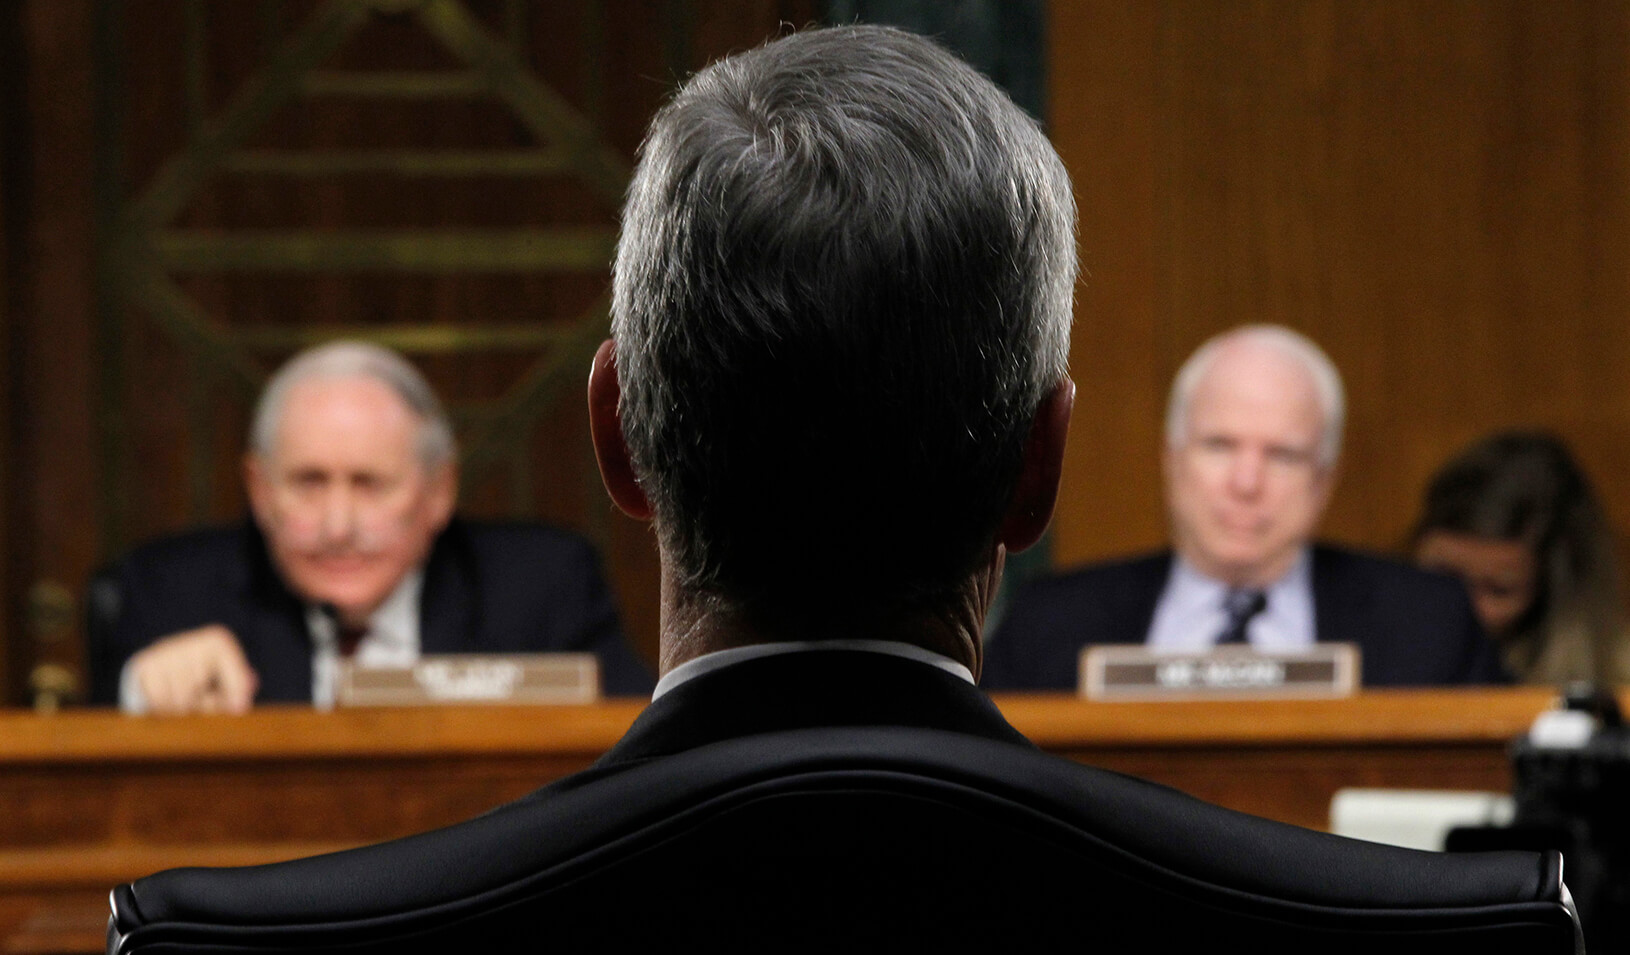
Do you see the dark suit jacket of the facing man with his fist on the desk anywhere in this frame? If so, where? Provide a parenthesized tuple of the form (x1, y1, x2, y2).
(90, 520, 652, 704)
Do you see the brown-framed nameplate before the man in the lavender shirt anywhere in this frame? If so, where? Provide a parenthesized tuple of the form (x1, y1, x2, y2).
(1079, 644, 1359, 699)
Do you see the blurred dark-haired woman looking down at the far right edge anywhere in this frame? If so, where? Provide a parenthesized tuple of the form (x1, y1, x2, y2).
(1412, 432, 1630, 686)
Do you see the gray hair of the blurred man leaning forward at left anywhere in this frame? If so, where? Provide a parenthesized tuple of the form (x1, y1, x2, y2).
(249, 341, 458, 469)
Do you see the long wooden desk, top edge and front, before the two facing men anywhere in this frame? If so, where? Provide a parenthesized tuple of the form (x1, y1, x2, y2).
(0, 688, 1553, 952)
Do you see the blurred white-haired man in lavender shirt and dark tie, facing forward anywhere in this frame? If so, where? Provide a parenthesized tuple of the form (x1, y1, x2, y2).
(985, 324, 1506, 689)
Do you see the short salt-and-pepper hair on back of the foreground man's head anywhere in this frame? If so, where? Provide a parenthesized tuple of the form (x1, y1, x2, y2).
(613, 26, 1076, 616)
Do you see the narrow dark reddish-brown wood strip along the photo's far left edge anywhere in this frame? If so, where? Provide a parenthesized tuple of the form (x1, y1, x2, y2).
(3, 3, 96, 701)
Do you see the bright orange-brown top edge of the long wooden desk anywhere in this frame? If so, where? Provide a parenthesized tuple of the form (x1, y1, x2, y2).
(0, 688, 1558, 768)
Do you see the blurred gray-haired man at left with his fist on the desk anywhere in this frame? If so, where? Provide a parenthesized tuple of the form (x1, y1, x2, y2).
(90, 341, 652, 714)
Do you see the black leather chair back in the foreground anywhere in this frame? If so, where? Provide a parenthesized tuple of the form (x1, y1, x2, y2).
(109, 728, 1579, 955)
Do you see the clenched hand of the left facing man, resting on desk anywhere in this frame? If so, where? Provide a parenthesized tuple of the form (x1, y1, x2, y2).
(130, 624, 261, 714)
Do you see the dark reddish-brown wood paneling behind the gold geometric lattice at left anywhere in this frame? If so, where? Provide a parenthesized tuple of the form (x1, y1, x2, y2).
(0, 0, 815, 702)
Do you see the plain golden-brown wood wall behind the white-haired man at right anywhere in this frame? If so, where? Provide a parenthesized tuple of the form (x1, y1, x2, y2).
(1050, 0, 1630, 564)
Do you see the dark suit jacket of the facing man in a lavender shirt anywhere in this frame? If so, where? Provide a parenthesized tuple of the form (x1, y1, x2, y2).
(981, 546, 1504, 691)
